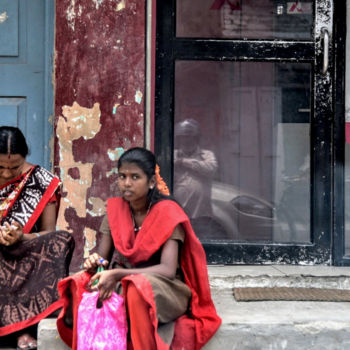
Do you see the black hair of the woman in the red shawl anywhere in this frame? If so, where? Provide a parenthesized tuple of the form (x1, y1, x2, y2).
(118, 147, 176, 205)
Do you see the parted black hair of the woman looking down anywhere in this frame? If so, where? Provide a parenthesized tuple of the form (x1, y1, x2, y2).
(0, 126, 28, 158)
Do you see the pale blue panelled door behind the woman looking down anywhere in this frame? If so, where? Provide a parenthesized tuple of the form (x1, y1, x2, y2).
(0, 0, 54, 167)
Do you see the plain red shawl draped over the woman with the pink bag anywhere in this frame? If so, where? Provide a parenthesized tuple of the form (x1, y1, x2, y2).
(57, 198, 221, 350)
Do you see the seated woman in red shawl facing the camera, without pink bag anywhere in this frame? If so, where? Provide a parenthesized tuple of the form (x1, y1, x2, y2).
(57, 148, 221, 350)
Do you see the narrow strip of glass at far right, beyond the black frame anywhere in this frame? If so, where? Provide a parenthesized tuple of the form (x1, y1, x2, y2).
(344, 2, 350, 255)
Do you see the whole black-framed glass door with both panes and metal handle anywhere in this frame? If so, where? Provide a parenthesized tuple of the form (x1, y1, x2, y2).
(155, 0, 333, 264)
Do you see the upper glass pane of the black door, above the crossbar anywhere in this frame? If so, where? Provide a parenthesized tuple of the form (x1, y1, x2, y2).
(176, 0, 313, 40)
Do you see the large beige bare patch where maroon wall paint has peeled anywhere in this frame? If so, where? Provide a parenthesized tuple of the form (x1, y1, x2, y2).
(56, 102, 101, 231)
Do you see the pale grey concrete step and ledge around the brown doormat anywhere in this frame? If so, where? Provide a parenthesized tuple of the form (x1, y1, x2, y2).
(0, 265, 350, 350)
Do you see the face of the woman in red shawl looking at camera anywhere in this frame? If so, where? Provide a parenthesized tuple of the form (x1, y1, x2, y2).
(118, 163, 155, 205)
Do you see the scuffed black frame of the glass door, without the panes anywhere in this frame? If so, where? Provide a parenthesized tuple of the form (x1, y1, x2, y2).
(155, 0, 333, 265)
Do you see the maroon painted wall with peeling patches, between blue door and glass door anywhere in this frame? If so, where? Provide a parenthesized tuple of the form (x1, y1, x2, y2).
(54, 0, 145, 271)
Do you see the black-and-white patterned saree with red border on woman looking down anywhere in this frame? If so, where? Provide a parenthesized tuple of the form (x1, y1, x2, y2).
(0, 166, 74, 336)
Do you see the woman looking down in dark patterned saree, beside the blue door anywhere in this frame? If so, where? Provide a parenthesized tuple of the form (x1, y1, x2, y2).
(0, 126, 74, 349)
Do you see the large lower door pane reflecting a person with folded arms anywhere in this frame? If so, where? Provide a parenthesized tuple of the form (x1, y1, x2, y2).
(174, 61, 311, 242)
